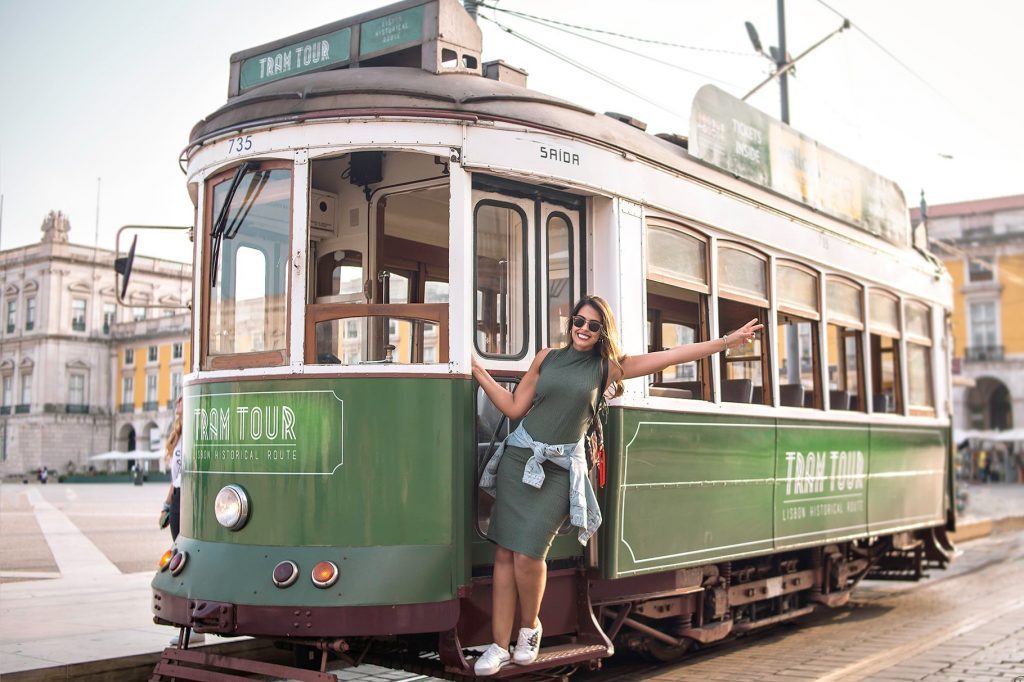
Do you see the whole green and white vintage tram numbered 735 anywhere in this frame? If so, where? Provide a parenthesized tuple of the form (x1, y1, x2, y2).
(140, 0, 955, 677)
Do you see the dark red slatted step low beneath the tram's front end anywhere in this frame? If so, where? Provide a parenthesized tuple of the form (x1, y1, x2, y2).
(150, 647, 338, 682)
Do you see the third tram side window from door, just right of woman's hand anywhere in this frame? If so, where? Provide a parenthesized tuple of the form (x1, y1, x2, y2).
(776, 263, 822, 408)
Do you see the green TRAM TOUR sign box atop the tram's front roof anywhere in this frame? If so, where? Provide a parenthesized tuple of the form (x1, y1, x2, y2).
(227, 0, 483, 98)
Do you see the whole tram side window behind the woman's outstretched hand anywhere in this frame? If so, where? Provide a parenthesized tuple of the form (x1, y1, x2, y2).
(718, 245, 771, 404)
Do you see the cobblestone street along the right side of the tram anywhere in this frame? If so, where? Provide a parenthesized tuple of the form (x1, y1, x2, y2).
(580, 531, 1024, 682)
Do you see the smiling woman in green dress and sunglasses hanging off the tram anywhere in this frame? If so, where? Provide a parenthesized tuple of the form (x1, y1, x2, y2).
(473, 296, 762, 675)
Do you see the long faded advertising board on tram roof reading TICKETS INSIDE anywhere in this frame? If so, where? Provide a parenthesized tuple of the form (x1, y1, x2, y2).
(689, 85, 909, 247)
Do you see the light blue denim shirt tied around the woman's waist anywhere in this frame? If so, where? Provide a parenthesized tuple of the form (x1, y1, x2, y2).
(480, 423, 601, 545)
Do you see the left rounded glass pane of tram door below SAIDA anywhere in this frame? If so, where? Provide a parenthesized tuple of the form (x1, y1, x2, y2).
(473, 201, 527, 357)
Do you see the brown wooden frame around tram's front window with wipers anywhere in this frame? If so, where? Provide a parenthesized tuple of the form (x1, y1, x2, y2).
(199, 159, 295, 370)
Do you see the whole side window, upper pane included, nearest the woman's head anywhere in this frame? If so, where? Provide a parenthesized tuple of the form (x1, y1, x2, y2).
(647, 220, 711, 400)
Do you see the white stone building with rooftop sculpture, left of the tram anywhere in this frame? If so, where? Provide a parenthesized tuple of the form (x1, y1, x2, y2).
(0, 212, 191, 474)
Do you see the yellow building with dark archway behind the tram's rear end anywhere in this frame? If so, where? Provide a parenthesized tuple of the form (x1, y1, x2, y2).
(911, 195, 1024, 430)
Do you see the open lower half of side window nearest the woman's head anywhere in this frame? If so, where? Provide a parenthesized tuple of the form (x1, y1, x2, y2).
(647, 280, 711, 400)
